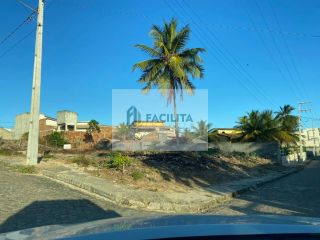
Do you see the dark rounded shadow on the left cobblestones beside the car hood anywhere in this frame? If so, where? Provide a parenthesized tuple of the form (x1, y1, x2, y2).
(0, 199, 121, 233)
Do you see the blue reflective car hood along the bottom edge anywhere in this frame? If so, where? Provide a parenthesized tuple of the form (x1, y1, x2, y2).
(0, 215, 320, 240)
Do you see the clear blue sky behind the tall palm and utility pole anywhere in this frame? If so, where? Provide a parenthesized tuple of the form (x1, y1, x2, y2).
(0, 0, 320, 127)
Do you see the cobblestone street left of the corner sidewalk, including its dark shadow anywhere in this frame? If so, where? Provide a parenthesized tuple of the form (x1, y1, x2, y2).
(0, 165, 141, 233)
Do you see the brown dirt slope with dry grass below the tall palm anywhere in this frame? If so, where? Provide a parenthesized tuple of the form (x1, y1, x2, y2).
(49, 151, 283, 192)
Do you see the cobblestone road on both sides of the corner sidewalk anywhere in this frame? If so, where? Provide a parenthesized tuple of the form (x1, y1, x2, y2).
(0, 161, 320, 233)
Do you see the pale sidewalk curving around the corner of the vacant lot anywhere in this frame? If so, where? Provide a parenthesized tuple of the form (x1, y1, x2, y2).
(0, 157, 304, 213)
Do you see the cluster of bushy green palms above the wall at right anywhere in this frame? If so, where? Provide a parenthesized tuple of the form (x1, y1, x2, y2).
(236, 105, 298, 145)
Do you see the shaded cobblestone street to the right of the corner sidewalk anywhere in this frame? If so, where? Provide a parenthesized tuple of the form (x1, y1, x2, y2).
(210, 161, 320, 217)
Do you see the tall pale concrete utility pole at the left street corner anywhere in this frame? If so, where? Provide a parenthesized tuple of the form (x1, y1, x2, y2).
(27, 0, 44, 165)
